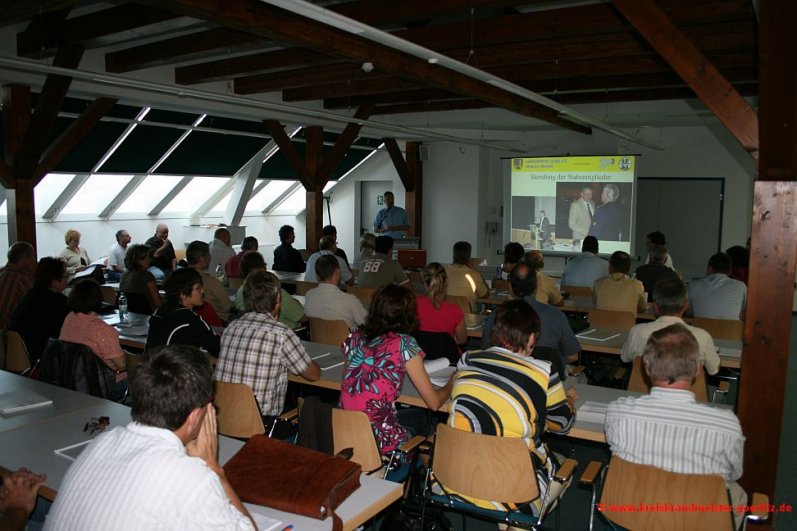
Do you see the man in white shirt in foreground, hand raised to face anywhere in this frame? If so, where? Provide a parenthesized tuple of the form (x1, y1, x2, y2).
(45, 346, 255, 531)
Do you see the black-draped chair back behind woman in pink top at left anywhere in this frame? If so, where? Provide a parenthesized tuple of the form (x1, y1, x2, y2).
(39, 338, 116, 398)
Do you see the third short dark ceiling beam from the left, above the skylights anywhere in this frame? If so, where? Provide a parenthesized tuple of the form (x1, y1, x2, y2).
(174, 48, 334, 85)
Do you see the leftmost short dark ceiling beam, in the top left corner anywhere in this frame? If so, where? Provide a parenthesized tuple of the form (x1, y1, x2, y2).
(17, 3, 191, 58)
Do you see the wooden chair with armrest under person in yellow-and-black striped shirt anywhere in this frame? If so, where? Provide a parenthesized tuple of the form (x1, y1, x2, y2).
(424, 424, 578, 527)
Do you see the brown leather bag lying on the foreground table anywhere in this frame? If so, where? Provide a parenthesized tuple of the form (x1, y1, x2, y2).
(224, 435, 362, 530)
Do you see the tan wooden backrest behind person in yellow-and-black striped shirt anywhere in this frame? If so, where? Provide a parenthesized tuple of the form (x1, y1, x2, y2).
(432, 424, 539, 503)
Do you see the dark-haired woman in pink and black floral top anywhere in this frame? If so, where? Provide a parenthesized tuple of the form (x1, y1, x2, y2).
(340, 285, 452, 454)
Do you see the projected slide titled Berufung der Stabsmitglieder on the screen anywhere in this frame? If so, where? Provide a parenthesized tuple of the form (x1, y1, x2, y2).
(509, 155, 636, 254)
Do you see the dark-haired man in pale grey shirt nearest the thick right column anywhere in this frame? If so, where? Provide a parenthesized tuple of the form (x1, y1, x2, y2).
(689, 253, 747, 320)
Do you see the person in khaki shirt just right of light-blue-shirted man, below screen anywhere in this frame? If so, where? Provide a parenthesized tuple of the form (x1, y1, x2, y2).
(592, 251, 648, 314)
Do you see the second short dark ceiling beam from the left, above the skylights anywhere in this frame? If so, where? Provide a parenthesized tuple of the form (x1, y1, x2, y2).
(105, 28, 266, 74)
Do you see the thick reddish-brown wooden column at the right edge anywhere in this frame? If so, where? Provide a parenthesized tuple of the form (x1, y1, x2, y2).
(738, 2, 797, 518)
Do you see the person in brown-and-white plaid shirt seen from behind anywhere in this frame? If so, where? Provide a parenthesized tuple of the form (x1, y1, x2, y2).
(216, 271, 321, 430)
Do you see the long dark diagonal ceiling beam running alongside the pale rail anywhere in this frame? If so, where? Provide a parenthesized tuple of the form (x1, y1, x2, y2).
(145, 0, 591, 133)
